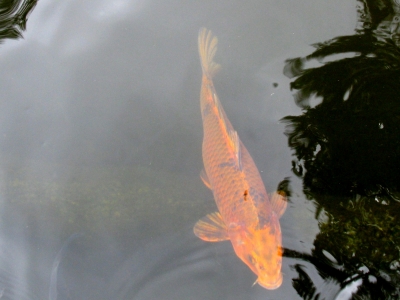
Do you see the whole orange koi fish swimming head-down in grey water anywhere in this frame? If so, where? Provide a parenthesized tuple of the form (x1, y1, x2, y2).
(193, 28, 287, 290)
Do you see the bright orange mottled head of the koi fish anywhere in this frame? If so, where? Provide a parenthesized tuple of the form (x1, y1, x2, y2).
(230, 213, 283, 290)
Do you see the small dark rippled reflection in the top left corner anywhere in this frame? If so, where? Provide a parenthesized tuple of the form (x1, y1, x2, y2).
(0, 0, 37, 43)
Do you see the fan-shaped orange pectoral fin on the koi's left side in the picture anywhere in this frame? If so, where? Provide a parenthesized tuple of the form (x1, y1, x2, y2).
(193, 212, 229, 242)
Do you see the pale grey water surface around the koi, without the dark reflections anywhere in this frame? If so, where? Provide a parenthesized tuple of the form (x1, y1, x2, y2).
(0, 0, 357, 300)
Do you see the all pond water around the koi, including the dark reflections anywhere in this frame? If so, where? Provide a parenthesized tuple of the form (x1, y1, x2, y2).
(0, 0, 400, 300)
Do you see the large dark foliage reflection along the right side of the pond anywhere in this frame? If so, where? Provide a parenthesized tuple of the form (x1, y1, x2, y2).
(283, 1, 400, 299)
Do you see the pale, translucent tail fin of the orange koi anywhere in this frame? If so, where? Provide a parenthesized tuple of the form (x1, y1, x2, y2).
(199, 27, 221, 78)
